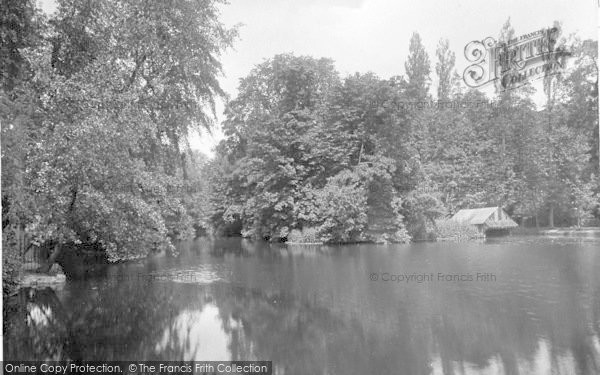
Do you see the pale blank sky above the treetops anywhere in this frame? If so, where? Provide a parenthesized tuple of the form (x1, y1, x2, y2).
(41, 0, 600, 156)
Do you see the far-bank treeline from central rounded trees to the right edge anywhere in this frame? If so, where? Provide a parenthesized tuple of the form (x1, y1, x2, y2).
(211, 22, 599, 242)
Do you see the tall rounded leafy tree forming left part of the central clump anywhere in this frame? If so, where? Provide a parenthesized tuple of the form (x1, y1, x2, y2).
(221, 55, 340, 237)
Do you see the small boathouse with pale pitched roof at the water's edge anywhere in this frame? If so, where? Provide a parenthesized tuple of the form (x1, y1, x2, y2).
(451, 207, 518, 234)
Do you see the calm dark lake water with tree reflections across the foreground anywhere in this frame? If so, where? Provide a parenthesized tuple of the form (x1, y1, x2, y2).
(4, 237, 600, 375)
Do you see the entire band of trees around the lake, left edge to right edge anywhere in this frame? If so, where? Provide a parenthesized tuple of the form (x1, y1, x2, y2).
(0, 0, 599, 284)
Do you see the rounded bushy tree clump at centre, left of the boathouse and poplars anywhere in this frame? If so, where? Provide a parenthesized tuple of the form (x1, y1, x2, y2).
(216, 55, 412, 242)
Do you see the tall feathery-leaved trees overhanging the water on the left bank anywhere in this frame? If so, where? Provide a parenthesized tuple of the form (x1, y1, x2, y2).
(0, 0, 236, 284)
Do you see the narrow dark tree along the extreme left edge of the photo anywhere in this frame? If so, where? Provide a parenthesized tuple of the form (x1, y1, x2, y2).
(0, 1, 44, 293)
